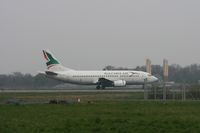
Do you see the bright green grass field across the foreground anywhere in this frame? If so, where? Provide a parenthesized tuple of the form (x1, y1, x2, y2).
(0, 94, 200, 133)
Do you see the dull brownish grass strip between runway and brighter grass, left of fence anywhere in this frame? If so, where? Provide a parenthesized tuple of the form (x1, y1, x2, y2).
(0, 92, 144, 104)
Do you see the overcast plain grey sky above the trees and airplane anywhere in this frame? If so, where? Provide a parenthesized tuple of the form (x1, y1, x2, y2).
(0, 0, 200, 74)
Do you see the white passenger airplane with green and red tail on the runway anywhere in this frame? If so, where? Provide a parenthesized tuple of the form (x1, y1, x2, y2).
(40, 50, 158, 89)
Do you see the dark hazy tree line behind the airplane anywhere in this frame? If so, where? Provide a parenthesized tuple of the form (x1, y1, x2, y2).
(0, 64, 200, 89)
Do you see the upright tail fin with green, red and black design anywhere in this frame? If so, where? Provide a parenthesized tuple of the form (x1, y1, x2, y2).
(43, 50, 71, 71)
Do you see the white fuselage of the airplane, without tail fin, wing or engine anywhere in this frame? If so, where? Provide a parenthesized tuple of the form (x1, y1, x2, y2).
(47, 70, 158, 85)
